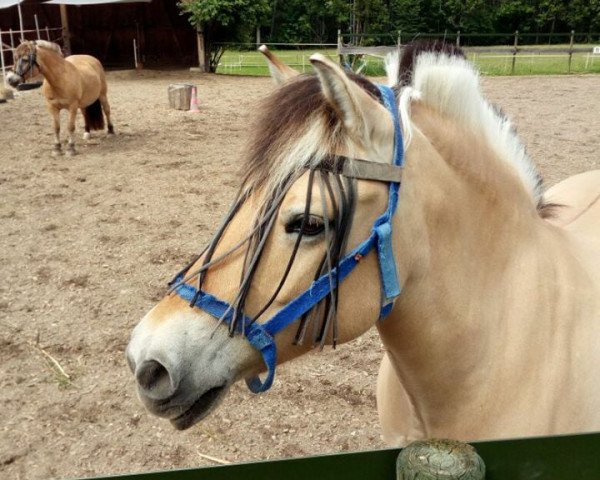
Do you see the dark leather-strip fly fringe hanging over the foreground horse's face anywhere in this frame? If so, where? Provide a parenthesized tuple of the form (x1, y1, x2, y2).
(176, 167, 356, 349)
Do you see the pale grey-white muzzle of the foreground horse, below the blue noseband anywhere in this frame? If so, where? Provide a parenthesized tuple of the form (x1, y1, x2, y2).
(125, 310, 237, 430)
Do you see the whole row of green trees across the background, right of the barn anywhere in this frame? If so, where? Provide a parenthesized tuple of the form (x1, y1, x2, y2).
(179, 0, 600, 66)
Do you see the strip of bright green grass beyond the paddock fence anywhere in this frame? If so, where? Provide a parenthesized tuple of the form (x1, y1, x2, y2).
(217, 45, 600, 76)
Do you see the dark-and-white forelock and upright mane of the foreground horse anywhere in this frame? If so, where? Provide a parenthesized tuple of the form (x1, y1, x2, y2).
(242, 42, 543, 212)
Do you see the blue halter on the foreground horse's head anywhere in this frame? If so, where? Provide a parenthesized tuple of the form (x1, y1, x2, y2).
(172, 85, 404, 393)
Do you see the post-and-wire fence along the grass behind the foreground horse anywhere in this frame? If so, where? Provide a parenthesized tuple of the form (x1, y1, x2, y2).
(217, 31, 600, 76)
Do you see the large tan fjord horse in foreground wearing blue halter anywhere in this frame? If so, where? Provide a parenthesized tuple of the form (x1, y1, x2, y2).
(127, 45, 600, 445)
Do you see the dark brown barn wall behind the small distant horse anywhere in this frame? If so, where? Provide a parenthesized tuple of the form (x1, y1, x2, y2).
(0, 0, 197, 68)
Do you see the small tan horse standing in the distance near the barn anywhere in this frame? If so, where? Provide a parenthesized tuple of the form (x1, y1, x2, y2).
(7, 40, 114, 155)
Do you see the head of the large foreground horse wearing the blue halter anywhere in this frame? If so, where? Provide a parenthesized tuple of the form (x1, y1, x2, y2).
(127, 52, 402, 429)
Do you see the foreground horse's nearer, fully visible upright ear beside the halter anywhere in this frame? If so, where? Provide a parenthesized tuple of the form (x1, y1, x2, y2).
(310, 53, 391, 142)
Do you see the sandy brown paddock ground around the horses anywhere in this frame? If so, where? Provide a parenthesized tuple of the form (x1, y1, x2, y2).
(0, 71, 600, 479)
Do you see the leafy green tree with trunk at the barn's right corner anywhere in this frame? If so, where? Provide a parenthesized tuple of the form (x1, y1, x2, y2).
(179, 0, 271, 72)
